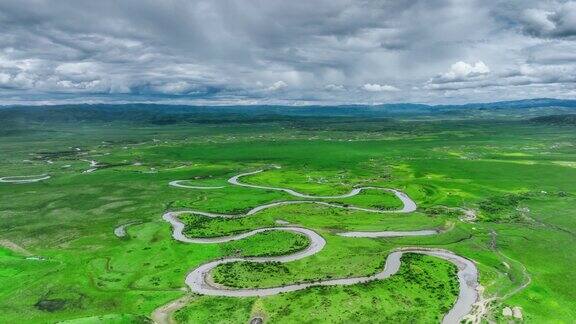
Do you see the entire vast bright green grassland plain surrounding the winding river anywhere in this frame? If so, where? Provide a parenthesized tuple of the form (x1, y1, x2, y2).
(0, 113, 576, 323)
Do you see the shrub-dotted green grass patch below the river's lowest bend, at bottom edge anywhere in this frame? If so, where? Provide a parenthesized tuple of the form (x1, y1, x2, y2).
(176, 254, 458, 323)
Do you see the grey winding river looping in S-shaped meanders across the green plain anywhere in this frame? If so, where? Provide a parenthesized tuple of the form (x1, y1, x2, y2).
(162, 170, 479, 323)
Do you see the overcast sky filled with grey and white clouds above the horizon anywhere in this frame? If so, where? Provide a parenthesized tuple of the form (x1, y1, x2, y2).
(0, 0, 576, 105)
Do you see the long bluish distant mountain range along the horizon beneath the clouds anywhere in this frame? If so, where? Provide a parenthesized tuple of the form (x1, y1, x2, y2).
(0, 98, 576, 124)
